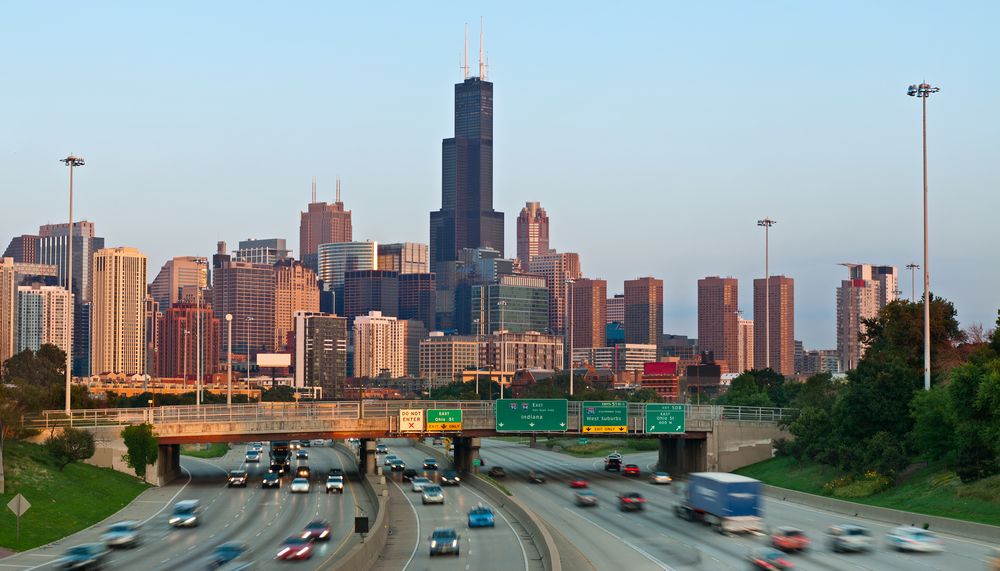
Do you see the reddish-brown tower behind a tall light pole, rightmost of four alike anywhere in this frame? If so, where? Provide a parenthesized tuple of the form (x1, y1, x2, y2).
(752, 276, 795, 375)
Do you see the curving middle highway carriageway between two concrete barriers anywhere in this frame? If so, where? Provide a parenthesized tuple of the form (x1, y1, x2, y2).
(379, 439, 542, 571)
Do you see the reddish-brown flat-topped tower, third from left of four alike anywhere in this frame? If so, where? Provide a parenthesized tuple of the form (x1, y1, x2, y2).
(698, 276, 740, 370)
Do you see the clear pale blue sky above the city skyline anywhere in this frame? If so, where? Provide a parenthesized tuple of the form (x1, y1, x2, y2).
(0, 1, 1000, 348)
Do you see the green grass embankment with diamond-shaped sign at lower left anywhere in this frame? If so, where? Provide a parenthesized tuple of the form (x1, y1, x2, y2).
(0, 440, 149, 551)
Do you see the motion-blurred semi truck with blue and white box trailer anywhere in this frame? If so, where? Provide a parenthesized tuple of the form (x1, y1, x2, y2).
(674, 472, 764, 533)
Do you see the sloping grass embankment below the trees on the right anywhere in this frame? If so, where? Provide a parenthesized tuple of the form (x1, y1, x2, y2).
(736, 456, 1000, 525)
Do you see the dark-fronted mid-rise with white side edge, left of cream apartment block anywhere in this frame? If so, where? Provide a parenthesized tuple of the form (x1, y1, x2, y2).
(293, 311, 347, 399)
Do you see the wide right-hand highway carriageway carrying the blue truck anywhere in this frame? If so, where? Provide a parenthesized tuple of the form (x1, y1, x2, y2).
(480, 439, 990, 571)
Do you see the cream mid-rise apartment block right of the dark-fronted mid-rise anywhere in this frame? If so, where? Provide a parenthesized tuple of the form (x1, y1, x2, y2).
(354, 311, 406, 378)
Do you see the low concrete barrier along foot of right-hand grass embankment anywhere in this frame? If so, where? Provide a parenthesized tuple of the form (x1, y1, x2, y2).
(763, 484, 1000, 542)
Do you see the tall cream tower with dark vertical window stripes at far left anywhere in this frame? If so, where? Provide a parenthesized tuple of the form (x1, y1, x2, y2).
(91, 248, 148, 375)
